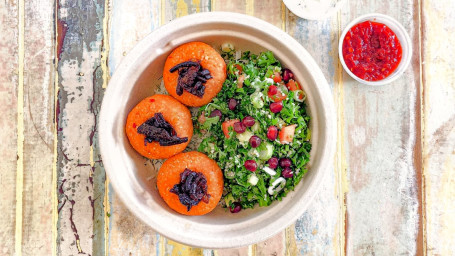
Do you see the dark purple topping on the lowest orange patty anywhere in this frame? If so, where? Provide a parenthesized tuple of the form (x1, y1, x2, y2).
(169, 168, 210, 211)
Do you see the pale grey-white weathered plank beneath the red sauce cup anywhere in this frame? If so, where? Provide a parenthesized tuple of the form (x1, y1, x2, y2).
(335, 0, 422, 255)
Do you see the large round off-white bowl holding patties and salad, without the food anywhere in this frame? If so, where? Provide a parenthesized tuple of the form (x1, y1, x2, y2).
(99, 12, 336, 248)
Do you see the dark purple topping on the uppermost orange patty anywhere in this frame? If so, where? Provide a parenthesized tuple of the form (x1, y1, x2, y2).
(169, 61, 212, 98)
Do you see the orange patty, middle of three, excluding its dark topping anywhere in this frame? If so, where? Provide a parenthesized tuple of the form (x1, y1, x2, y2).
(125, 94, 193, 159)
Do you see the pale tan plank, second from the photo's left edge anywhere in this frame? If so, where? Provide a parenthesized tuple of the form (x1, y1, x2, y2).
(22, 0, 55, 255)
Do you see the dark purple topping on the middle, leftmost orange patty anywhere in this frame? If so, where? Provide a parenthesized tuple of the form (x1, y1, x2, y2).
(137, 113, 188, 146)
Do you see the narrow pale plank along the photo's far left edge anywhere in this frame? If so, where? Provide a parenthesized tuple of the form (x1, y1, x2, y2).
(0, 1, 19, 255)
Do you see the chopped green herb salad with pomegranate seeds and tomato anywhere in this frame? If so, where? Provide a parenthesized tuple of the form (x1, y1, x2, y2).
(194, 45, 311, 213)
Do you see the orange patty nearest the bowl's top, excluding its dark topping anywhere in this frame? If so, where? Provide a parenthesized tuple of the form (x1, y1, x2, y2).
(163, 42, 226, 107)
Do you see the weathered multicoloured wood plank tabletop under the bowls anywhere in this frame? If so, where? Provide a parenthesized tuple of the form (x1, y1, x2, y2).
(0, 0, 455, 256)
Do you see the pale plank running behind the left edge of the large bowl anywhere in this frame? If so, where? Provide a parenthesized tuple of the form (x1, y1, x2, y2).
(106, 0, 161, 255)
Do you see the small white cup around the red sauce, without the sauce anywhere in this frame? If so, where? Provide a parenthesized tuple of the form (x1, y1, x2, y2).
(338, 13, 412, 86)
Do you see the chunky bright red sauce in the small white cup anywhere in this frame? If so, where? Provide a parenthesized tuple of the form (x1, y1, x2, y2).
(343, 21, 402, 81)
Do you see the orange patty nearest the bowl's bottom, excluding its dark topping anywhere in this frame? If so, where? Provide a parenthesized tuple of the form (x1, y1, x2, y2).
(157, 151, 224, 215)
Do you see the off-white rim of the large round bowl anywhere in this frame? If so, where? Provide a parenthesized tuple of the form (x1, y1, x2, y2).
(99, 12, 336, 249)
